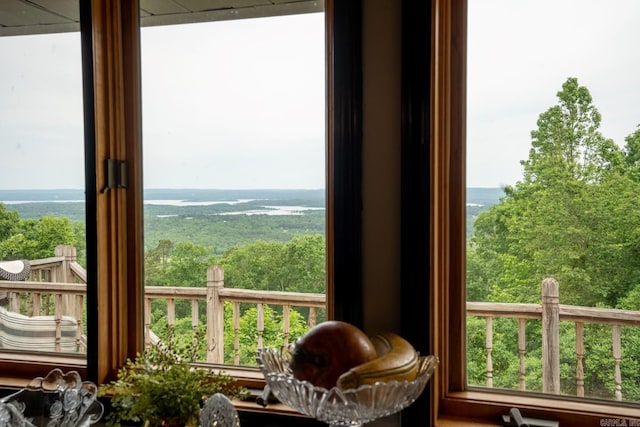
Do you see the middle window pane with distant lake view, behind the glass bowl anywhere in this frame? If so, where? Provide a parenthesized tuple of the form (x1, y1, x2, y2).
(142, 8, 326, 366)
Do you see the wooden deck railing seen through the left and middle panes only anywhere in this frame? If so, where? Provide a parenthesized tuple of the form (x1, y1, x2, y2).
(0, 246, 326, 364)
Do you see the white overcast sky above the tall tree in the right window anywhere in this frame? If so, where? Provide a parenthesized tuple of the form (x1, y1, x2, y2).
(467, 0, 640, 187)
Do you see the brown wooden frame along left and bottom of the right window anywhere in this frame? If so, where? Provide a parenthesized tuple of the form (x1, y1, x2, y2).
(423, 0, 639, 426)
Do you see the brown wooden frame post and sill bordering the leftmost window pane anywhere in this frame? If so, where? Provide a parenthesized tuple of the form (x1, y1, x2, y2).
(0, 0, 144, 387)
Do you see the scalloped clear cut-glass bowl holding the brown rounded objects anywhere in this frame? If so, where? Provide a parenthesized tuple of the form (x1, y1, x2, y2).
(256, 348, 439, 427)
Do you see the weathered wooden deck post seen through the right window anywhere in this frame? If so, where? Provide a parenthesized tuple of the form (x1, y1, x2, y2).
(542, 278, 560, 394)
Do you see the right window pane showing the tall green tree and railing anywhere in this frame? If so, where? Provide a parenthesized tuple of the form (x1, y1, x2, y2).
(467, 0, 640, 401)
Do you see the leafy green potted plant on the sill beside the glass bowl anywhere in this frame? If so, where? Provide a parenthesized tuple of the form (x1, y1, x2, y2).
(99, 345, 248, 427)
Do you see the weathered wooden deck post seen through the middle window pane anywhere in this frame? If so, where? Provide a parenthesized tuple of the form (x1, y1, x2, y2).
(207, 265, 224, 363)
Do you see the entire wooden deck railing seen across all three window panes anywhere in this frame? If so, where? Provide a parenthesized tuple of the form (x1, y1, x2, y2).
(0, 246, 640, 400)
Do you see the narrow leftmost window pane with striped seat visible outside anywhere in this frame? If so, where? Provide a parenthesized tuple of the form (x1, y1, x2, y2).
(0, 2, 86, 358)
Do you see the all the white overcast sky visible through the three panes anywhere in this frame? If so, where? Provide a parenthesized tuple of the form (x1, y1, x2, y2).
(0, 0, 640, 189)
